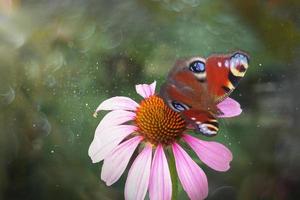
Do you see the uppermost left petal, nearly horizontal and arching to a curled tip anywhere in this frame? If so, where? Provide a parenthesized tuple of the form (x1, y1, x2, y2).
(96, 97, 139, 113)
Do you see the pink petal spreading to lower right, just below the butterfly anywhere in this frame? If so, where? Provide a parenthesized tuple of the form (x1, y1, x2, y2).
(183, 134, 232, 171)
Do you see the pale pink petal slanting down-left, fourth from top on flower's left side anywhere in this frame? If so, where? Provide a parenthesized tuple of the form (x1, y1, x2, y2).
(101, 136, 142, 186)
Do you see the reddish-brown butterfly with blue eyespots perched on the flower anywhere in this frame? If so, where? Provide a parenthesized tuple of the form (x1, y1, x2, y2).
(160, 51, 249, 136)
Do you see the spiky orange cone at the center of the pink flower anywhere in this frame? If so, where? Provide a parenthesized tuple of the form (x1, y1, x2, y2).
(135, 95, 186, 145)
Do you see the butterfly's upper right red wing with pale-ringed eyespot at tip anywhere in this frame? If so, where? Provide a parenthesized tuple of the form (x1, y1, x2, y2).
(206, 51, 249, 102)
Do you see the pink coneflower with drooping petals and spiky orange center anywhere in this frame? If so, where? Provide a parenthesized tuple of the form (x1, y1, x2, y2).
(89, 82, 241, 200)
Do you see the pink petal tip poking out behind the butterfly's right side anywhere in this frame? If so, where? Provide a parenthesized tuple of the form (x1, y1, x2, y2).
(217, 97, 242, 118)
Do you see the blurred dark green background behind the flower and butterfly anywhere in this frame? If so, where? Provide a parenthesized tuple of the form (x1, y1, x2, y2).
(0, 0, 300, 200)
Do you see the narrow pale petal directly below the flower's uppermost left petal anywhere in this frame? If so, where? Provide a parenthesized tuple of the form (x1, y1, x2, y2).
(96, 110, 136, 135)
